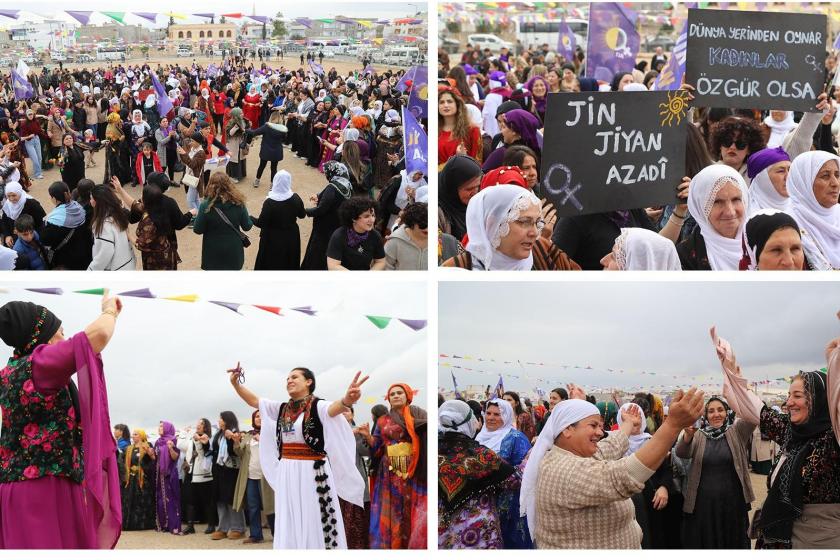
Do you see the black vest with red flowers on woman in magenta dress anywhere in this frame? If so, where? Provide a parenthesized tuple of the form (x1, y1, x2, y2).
(0, 356, 84, 483)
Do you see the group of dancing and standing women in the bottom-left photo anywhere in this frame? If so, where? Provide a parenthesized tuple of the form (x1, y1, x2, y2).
(0, 291, 427, 549)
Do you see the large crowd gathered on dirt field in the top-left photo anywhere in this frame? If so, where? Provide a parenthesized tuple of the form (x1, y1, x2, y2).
(0, 56, 428, 270)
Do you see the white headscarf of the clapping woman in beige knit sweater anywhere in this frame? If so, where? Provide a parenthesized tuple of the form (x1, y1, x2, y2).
(519, 399, 601, 539)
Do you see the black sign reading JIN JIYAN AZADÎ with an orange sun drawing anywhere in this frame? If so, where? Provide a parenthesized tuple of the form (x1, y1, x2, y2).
(541, 90, 688, 216)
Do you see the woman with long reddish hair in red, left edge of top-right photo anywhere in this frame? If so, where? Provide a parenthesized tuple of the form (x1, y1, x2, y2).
(438, 86, 482, 169)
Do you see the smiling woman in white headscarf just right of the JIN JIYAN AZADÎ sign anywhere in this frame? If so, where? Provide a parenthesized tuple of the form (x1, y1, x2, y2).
(677, 164, 747, 270)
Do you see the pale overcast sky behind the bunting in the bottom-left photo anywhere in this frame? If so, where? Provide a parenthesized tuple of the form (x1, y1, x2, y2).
(0, 282, 428, 436)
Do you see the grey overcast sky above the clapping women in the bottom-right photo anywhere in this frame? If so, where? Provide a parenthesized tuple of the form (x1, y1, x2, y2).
(438, 282, 840, 392)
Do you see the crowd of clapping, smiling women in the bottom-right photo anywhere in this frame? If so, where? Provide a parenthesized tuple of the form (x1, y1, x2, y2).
(438, 329, 840, 549)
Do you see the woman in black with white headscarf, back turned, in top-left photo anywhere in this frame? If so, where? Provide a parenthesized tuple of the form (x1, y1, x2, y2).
(251, 169, 306, 270)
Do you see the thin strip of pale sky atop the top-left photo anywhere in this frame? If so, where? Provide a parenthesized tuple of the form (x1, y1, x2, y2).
(0, 0, 427, 27)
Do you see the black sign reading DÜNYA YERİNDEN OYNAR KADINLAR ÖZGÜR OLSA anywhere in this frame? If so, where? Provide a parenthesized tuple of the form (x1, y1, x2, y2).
(685, 9, 827, 112)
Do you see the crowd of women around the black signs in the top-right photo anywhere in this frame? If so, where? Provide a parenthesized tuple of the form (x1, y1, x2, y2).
(438, 35, 840, 270)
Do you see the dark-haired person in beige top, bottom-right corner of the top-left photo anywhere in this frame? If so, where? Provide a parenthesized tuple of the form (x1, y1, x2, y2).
(385, 202, 429, 270)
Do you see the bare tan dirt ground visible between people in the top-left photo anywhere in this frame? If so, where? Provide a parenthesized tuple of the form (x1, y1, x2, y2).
(27, 53, 406, 270)
